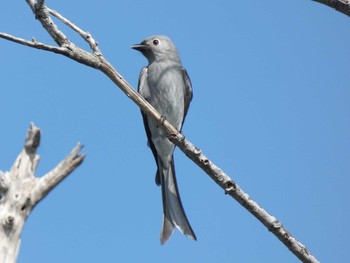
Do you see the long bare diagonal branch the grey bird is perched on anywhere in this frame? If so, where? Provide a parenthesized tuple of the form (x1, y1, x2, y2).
(0, 0, 318, 262)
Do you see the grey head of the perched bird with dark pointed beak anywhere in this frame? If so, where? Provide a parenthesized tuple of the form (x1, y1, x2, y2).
(131, 35, 180, 64)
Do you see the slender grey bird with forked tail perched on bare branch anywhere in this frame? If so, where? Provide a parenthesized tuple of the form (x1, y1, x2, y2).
(132, 36, 196, 244)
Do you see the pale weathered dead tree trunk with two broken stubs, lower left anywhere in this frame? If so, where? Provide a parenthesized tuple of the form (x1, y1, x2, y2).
(0, 123, 85, 263)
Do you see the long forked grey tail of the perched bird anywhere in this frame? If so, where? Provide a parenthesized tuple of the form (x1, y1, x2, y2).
(159, 158, 197, 245)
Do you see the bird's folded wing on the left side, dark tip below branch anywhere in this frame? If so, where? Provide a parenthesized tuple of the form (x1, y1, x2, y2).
(138, 67, 160, 185)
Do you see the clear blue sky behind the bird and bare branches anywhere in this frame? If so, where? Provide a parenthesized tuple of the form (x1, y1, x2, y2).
(0, 0, 350, 263)
